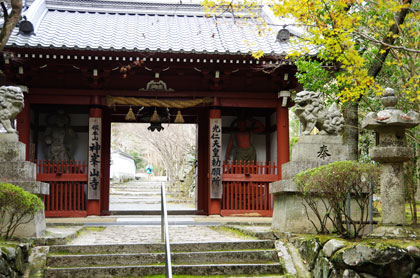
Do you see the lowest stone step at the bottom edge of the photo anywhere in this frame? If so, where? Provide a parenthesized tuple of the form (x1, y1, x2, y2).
(45, 263, 282, 278)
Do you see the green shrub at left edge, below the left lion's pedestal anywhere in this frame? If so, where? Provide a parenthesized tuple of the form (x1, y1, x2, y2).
(0, 183, 44, 239)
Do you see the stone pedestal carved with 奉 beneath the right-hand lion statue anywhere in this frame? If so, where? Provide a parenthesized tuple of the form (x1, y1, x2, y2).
(270, 135, 356, 233)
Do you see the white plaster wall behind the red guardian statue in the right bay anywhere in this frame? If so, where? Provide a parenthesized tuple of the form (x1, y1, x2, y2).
(222, 116, 266, 162)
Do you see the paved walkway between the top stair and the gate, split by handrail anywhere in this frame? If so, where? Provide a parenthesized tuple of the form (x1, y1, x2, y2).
(46, 216, 271, 245)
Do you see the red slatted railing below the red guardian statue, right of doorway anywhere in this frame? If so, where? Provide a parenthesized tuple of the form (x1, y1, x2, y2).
(222, 161, 278, 216)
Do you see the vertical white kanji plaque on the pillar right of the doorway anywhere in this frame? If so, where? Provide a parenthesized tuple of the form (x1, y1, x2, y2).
(210, 118, 223, 199)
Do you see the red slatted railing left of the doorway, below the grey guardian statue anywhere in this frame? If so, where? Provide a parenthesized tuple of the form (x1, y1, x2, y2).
(36, 160, 88, 217)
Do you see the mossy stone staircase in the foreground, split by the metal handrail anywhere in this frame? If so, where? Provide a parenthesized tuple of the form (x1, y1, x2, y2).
(45, 240, 283, 278)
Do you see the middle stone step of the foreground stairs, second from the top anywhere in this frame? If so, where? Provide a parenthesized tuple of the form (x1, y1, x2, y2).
(47, 250, 279, 267)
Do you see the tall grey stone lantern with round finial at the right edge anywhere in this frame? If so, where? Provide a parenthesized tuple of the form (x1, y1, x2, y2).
(362, 88, 419, 226)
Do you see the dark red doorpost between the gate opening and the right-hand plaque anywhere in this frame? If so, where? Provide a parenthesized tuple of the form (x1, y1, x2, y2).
(197, 109, 210, 214)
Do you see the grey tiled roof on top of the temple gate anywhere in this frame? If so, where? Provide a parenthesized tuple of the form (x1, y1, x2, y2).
(8, 0, 316, 55)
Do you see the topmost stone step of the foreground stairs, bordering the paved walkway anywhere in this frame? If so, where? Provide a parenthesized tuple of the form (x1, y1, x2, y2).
(50, 240, 275, 254)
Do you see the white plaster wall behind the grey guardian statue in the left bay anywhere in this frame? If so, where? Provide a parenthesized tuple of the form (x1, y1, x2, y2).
(36, 113, 89, 162)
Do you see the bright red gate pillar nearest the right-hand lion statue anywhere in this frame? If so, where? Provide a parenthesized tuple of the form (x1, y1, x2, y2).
(276, 100, 289, 179)
